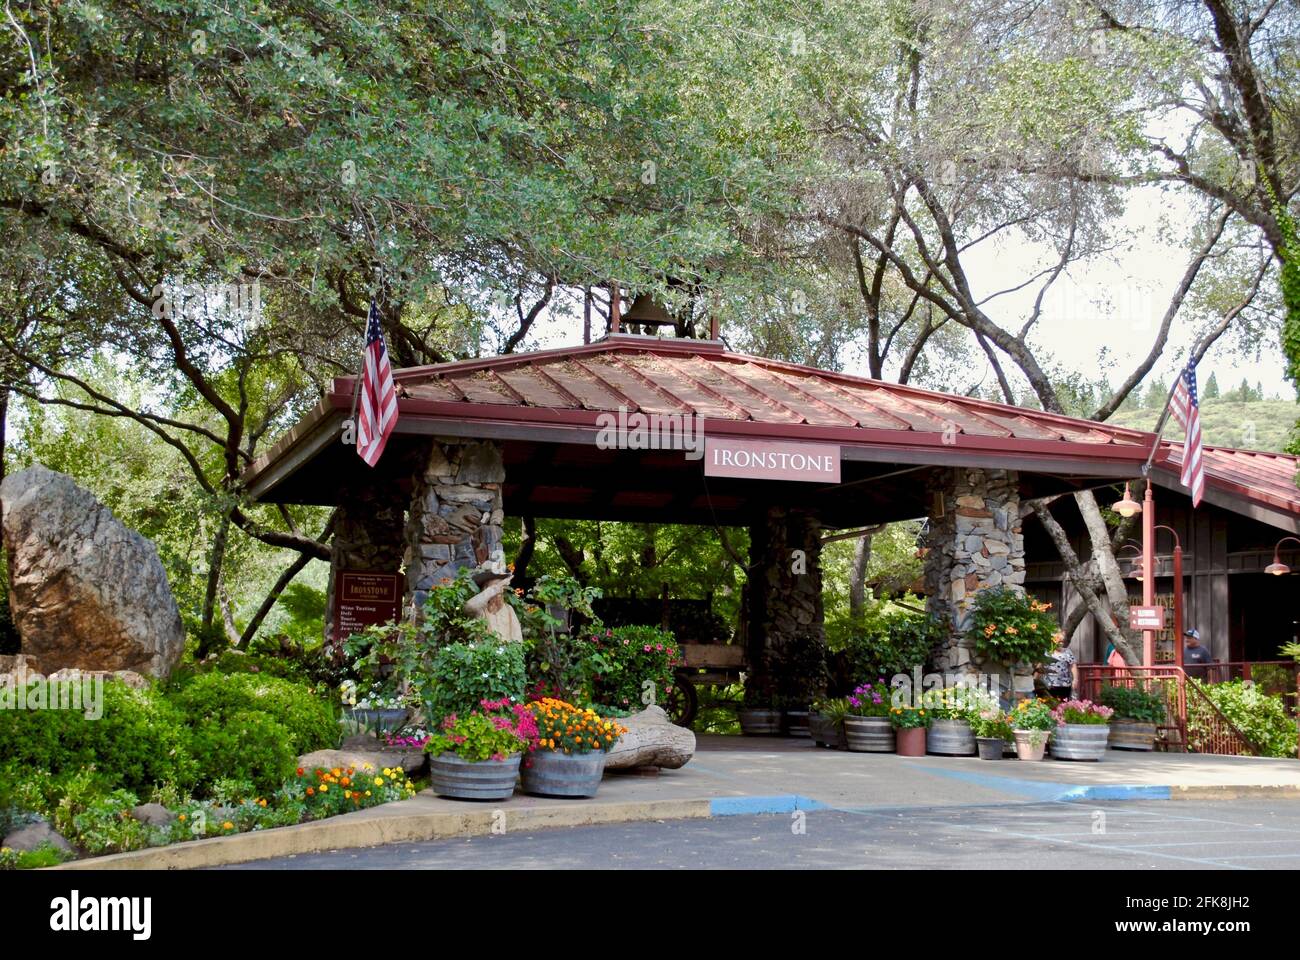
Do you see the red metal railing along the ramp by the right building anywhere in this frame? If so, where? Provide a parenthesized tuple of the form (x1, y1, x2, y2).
(1079, 661, 1268, 756)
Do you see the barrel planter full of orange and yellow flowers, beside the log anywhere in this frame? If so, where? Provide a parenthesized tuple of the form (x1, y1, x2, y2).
(520, 697, 628, 796)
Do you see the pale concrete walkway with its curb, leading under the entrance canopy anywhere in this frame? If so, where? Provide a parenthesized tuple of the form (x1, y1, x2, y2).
(56, 735, 1300, 869)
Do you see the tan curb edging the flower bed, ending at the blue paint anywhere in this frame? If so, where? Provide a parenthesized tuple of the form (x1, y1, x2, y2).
(48, 797, 711, 870)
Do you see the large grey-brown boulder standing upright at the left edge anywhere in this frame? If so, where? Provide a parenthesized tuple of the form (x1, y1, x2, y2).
(0, 466, 185, 676)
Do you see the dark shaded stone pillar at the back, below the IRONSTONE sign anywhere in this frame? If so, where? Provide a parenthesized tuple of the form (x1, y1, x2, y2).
(745, 507, 826, 708)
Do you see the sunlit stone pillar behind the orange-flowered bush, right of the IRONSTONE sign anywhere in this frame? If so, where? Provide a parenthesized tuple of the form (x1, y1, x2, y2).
(926, 467, 1034, 689)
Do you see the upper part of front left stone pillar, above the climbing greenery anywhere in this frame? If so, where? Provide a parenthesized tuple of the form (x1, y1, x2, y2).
(406, 437, 506, 615)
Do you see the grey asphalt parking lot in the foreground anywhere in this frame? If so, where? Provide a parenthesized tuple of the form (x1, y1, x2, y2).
(230, 800, 1300, 870)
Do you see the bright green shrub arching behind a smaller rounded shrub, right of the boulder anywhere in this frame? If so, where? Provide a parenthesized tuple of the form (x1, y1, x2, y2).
(172, 674, 339, 749)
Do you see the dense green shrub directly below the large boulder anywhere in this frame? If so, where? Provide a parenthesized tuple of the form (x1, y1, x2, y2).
(0, 680, 196, 792)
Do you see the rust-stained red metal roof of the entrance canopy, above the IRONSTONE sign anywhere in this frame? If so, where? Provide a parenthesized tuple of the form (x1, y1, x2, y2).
(353, 336, 1152, 460)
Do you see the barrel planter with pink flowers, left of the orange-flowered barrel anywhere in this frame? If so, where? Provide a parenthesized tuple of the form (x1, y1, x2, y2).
(424, 700, 537, 800)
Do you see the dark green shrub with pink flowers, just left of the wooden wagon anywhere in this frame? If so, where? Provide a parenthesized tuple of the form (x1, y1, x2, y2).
(580, 627, 683, 710)
